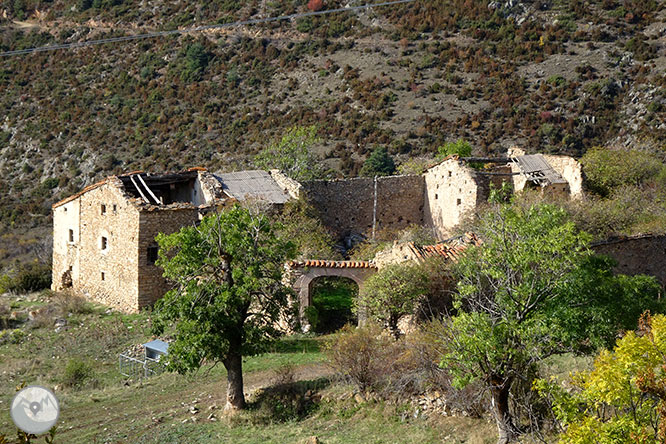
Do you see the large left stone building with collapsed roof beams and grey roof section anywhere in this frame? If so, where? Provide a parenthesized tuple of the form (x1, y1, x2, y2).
(52, 169, 289, 312)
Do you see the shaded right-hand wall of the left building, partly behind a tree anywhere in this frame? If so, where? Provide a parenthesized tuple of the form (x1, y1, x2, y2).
(135, 208, 199, 308)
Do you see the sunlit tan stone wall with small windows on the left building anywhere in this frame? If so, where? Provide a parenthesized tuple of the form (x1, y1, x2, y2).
(73, 178, 139, 312)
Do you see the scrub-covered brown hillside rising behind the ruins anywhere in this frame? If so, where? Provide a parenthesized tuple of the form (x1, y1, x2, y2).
(0, 0, 666, 263)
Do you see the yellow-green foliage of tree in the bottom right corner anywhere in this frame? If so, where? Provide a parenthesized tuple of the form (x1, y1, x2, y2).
(535, 314, 666, 444)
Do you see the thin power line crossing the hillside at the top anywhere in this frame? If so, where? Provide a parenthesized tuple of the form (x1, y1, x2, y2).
(0, 0, 416, 57)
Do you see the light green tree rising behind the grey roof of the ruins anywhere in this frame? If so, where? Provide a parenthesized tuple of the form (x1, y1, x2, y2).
(254, 125, 323, 181)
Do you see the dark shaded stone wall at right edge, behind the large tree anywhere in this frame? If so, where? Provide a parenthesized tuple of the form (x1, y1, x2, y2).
(592, 235, 666, 286)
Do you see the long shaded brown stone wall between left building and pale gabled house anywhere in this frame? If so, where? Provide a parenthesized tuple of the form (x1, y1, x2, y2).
(302, 176, 425, 243)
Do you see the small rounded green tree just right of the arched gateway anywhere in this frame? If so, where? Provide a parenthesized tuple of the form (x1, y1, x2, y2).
(355, 262, 429, 339)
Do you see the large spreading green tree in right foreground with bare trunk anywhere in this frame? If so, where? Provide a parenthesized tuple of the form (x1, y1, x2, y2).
(442, 204, 659, 443)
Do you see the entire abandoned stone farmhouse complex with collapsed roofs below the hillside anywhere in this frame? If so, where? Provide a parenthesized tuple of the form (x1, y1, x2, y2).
(52, 152, 582, 312)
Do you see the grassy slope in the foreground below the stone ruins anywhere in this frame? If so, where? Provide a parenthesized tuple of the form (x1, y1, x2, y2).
(0, 295, 494, 444)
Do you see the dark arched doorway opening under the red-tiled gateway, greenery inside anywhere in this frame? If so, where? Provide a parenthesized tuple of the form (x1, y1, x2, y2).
(305, 276, 358, 334)
